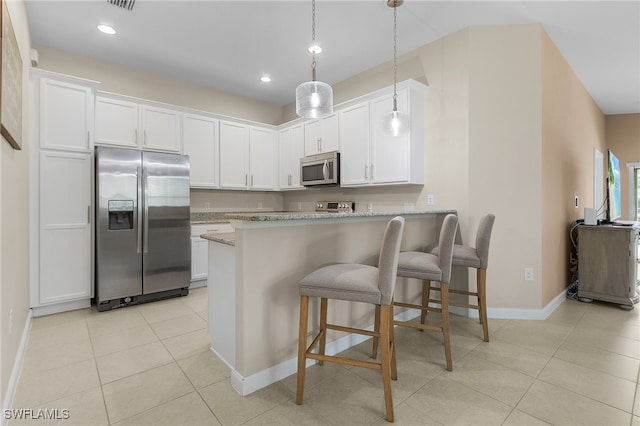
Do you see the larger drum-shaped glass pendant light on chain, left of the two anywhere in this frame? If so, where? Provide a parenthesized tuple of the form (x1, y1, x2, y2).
(296, 0, 333, 118)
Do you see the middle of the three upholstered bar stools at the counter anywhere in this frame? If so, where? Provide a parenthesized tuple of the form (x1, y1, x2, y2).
(393, 214, 458, 371)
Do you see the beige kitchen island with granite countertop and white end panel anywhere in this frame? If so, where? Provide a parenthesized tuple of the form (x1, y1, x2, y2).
(202, 210, 458, 395)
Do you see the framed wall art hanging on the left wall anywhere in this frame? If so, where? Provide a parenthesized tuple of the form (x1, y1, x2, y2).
(0, 0, 22, 149)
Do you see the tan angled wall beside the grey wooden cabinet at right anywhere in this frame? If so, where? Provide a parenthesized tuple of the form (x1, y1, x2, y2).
(541, 32, 606, 305)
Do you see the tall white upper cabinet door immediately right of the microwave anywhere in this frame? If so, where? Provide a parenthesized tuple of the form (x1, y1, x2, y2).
(340, 103, 373, 186)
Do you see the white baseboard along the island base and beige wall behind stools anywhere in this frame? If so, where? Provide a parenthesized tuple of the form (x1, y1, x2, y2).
(222, 290, 566, 396)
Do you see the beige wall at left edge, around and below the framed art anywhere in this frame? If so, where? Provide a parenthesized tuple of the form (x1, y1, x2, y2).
(0, 1, 31, 408)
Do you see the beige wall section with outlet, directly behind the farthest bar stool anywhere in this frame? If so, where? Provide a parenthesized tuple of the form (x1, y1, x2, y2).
(467, 25, 544, 309)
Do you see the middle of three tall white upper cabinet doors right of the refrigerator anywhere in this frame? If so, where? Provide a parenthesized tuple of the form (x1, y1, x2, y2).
(219, 121, 249, 189)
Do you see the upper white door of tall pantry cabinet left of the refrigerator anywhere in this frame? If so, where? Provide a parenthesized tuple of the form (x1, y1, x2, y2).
(40, 78, 94, 152)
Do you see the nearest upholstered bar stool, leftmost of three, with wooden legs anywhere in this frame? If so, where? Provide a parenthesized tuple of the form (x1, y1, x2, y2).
(296, 216, 404, 422)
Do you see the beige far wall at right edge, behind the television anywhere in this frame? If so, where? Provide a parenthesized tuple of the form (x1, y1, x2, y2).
(605, 114, 640, 220)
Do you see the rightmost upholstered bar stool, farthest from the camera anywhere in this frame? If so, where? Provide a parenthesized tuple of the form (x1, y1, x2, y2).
(426, 214, 496, 342)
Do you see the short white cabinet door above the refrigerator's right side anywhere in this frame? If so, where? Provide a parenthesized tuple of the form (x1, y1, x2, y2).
(140, 105, 182, 152)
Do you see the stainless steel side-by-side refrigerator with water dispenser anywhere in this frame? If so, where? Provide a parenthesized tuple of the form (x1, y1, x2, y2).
(95, 147, 191, 311)
